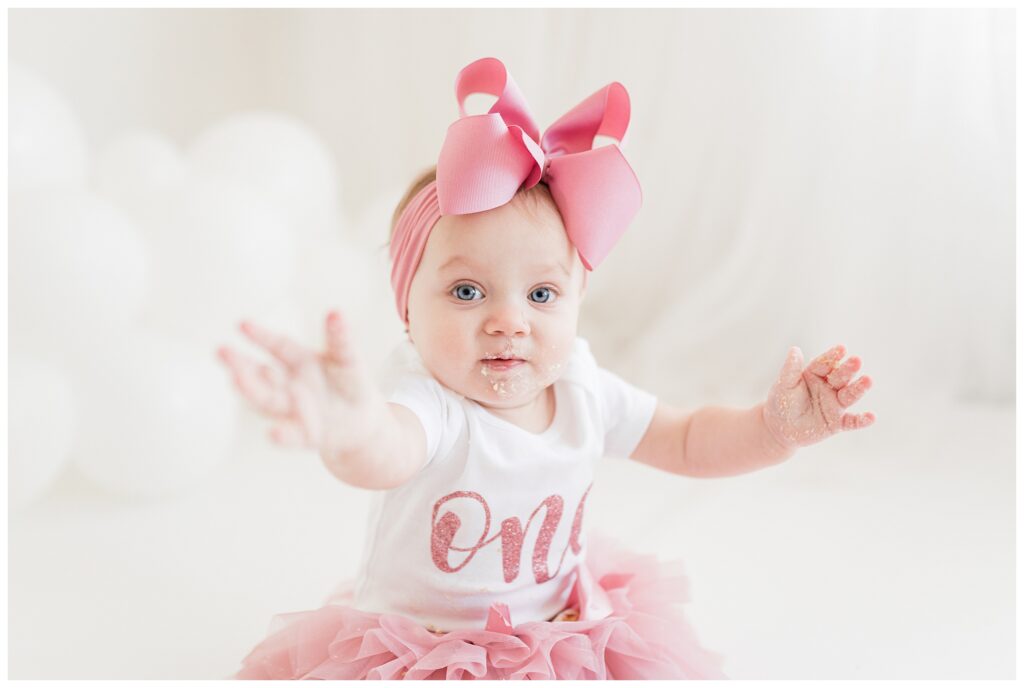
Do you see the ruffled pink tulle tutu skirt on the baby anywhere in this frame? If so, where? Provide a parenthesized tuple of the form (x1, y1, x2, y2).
(234, 536, 726, 680)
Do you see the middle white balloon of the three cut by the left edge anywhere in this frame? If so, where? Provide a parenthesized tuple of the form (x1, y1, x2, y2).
(8, 189, 146, 358)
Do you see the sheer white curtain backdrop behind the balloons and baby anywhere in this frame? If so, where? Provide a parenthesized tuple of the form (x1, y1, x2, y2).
(10, 9, 1014, 403)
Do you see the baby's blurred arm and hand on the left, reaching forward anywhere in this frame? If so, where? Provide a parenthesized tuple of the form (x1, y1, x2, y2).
(217, 312, 426, 489)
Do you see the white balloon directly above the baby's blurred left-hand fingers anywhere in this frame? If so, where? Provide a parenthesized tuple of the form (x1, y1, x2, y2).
(139, 174, 295, 336)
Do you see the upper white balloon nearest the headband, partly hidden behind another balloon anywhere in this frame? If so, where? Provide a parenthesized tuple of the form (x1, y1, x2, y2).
(187, 112, 338, 230)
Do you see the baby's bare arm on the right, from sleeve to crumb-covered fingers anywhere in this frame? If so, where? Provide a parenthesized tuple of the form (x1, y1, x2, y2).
(632, 345, 874, 478)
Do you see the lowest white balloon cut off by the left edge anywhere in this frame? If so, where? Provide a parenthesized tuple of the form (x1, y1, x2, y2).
(7, 354, 76, 509)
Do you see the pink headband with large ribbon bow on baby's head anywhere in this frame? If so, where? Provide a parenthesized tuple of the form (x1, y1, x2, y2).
(391, 57, 642, 325)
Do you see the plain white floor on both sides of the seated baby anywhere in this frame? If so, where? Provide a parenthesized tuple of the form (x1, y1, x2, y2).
(8, 395, 1016, 679)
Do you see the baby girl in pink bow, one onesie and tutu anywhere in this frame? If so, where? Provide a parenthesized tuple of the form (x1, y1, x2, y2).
(219, 58, 874, 679)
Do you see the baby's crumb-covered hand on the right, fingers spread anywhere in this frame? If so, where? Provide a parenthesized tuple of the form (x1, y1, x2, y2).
(763, 344, 874, 448)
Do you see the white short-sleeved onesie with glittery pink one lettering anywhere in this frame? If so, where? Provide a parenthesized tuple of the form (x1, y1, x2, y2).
(352, 338, 656, 631)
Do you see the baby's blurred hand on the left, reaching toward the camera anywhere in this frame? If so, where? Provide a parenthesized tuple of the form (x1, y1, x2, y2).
(217, 311, 385, 454)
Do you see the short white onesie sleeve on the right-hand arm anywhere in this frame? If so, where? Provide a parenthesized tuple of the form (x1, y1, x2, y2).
(597, 368, 657, 458)
